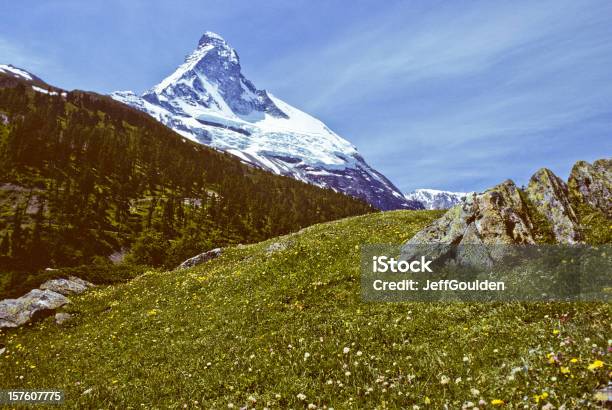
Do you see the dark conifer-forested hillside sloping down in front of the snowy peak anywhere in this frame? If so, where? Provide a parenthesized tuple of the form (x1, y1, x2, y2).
(0, 75, 372, 270)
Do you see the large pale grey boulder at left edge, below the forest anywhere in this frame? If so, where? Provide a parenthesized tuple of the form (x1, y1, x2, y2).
(0, 289, 69, 328)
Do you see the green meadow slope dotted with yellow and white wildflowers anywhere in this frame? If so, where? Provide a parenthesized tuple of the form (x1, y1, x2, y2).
(0, 211, 612, 408)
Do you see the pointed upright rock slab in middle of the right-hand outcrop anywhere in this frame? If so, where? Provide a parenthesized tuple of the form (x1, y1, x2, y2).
(525, 168, 580, 244)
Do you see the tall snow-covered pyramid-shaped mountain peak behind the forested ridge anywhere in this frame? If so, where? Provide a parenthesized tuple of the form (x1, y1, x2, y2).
(112, 32, 422, 210)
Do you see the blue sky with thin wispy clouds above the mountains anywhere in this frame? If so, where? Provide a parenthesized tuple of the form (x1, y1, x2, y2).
(0, 0, 612, 191)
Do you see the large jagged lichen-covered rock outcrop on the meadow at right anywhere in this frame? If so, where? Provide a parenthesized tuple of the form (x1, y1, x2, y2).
(405, 159, 612, 252)
